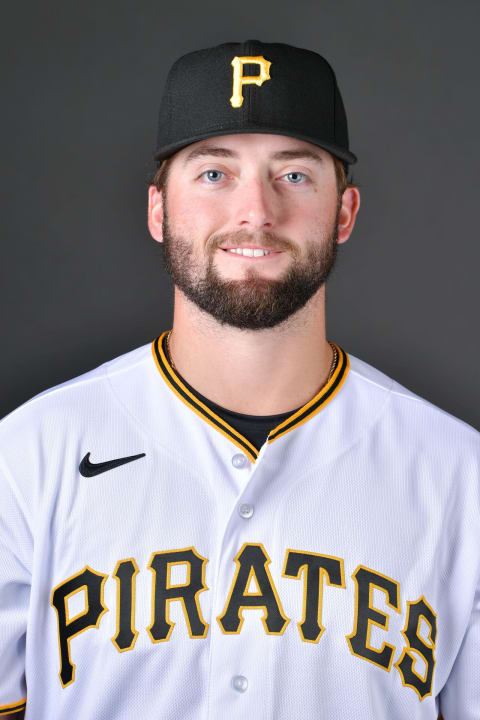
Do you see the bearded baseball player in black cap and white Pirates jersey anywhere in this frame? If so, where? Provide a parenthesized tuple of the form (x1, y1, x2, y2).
(0, 40, 480, 720)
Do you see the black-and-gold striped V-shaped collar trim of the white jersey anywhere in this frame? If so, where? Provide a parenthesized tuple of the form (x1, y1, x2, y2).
(152, 330, 350, 462)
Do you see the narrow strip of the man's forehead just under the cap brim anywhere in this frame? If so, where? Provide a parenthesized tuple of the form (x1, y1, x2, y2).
(174, 133, 331, 167)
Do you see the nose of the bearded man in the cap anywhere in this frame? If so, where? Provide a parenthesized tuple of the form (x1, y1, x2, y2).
(235, 177, 277, 230)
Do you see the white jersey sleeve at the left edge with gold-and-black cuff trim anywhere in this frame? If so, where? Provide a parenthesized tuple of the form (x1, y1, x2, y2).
(0, 458, 33, 717)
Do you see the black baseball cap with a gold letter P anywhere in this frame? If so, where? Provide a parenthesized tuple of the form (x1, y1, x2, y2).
(154, 40, 357, 170)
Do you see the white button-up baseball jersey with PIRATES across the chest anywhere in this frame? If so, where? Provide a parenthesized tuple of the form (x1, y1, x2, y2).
(0, 333, 480, 720)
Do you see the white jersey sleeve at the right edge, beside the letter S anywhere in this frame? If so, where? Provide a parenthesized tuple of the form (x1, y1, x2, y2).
(440, 579, 480, 720)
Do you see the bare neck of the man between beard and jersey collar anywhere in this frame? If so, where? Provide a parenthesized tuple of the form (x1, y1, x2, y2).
(169, 287, 333, 415)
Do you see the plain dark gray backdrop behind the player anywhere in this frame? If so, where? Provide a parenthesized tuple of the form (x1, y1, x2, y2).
(0, 0, 480, 428)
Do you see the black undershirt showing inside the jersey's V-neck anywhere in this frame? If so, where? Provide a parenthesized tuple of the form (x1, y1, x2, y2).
(162, 336, 303, 450)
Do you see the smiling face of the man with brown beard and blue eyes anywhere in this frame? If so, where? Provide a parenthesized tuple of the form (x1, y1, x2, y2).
(151, 134, 350, 330)
